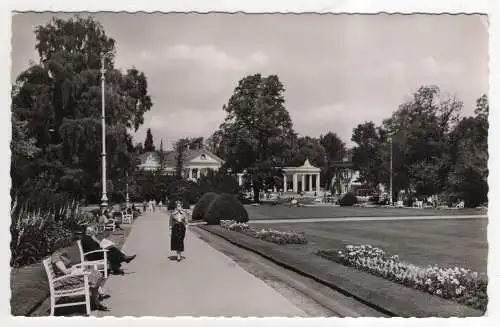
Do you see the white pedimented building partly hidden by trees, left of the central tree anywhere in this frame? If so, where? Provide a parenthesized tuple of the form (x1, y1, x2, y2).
(138, 148, 224, 181)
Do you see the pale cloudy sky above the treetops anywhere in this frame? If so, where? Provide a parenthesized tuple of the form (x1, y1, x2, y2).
(12, 13, 488, 150)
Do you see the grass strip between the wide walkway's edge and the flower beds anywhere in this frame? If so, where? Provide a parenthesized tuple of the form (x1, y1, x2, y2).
(199, 226, 484, 317)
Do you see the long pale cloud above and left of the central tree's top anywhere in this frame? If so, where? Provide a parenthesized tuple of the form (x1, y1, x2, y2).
(165, 44, 269, 71)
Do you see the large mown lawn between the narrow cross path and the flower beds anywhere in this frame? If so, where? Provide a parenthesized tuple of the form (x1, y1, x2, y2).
(252, 218, 488, 273)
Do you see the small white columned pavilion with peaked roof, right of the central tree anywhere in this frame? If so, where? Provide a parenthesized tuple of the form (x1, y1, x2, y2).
(283, 159, 321, 193)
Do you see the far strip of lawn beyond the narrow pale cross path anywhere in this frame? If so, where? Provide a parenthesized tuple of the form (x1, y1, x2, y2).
(245, 204, 487, 220)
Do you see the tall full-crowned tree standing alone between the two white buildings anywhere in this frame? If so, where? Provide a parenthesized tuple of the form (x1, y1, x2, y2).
(212, 74, 296, 201)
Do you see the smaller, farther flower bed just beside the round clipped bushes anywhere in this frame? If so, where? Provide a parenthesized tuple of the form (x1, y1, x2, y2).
(220, 220, 307, 244)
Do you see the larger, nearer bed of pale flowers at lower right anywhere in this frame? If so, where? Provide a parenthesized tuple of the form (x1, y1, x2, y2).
(316, 245, 488, 311)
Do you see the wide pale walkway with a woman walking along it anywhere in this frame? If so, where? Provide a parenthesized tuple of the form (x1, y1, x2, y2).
(94, 212, 305, 317)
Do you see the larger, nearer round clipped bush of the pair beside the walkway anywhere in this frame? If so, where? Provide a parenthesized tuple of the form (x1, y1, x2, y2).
(203, 194, 248, 225)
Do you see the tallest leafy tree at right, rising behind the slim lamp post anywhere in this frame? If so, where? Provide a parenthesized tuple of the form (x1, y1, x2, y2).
(384, 86, 463, 196)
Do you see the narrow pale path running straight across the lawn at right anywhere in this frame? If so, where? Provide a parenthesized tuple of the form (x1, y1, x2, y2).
(252, 215, 488, 224)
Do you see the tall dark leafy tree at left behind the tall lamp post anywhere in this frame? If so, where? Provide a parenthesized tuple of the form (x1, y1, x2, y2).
(12, 16, 152, 202)
